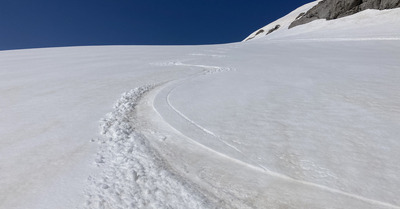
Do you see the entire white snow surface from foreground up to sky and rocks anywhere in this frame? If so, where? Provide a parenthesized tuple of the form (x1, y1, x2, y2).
(0, 4, 400, 209)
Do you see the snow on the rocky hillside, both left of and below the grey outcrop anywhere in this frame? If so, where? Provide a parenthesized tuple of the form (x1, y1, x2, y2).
(244, 1, 400, 41)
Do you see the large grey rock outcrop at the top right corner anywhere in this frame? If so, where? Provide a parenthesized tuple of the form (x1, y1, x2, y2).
(289, 0, 400, 28)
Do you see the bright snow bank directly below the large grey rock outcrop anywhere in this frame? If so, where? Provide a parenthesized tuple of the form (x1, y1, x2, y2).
(258, 8, 400, 41)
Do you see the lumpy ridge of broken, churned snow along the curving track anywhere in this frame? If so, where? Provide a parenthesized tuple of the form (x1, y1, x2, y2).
(84, 86, 213, 209)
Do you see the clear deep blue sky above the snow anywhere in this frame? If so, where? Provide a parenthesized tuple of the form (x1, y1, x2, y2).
(0, 0, 311, 50)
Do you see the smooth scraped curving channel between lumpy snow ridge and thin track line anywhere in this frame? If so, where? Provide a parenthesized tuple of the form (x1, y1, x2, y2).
(134, 57, 398, 208)
